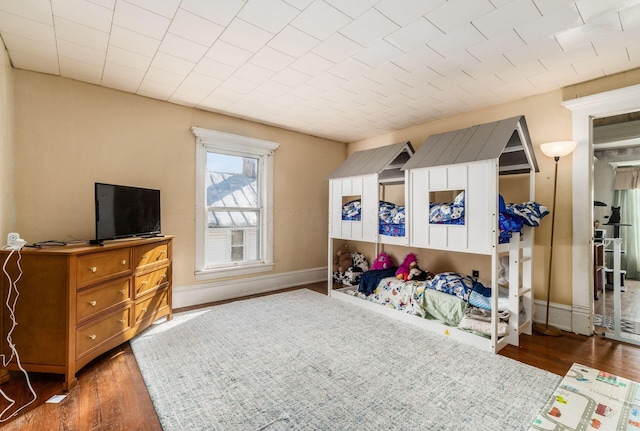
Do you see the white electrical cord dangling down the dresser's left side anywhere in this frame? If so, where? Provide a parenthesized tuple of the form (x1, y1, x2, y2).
(0, 248, 38, 423)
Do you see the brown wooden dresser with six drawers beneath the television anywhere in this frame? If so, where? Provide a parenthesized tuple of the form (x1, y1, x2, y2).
(0, 236, 173, 389)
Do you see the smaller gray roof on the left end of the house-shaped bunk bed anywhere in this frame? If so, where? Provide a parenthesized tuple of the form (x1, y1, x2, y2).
(329, 142, 415, 184)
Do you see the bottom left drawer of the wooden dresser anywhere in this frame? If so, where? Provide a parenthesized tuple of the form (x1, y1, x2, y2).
(76, 306, 131, 360)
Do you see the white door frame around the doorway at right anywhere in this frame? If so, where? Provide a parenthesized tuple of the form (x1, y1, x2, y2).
(562, 85, 640, 335)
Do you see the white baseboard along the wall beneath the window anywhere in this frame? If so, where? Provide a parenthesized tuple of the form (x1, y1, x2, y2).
(173, 267, 328, 308)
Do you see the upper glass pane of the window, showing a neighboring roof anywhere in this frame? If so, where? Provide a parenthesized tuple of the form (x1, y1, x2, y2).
(210, 152, 259, 208)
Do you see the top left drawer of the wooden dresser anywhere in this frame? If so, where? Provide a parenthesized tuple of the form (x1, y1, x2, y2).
(76, 248, 132, 287)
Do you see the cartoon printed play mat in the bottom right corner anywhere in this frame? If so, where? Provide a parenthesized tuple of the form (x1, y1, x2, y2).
(529, 364, 640, 431)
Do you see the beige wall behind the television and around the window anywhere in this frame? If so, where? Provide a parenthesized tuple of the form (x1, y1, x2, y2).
(12, 70, 346, 286)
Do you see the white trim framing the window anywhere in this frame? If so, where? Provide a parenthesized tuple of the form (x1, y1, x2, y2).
(191, 127, 280, 281)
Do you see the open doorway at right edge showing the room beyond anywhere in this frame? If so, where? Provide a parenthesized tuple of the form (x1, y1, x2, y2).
(592, 111, 640, 342)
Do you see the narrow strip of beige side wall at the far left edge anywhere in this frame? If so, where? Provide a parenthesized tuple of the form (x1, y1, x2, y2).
(0, 39, 15, 240)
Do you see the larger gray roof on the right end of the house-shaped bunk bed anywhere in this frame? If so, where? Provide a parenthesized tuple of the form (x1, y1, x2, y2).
(402, 115, 539, 175)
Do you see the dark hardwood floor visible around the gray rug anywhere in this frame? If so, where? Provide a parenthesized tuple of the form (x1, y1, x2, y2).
(0, 283, 640, 431)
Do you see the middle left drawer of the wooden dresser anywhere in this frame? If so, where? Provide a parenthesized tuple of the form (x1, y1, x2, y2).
(76, 277, 131, 322)
